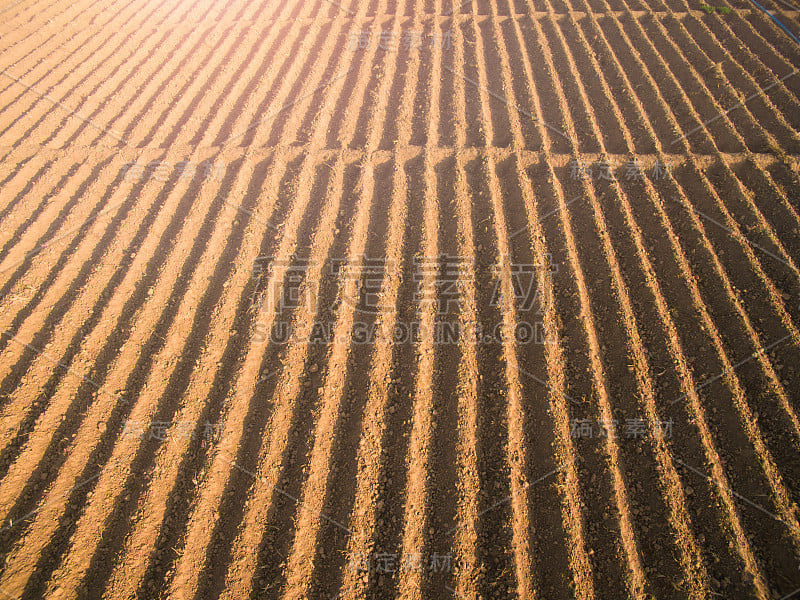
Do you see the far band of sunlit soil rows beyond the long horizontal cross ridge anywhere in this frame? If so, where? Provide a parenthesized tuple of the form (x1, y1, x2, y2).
(0, 4, 800, 156)
